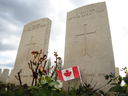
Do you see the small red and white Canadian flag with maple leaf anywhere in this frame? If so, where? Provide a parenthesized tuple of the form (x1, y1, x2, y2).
(57, 66, 80, 81)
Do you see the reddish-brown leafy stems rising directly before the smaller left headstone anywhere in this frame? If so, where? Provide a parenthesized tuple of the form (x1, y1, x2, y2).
(28, 50, 47, 86)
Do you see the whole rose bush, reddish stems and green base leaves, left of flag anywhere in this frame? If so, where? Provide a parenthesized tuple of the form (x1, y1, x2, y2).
(28, 51, 61, 93)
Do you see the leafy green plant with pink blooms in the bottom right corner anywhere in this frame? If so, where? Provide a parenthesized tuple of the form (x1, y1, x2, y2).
(105, 67, 128, 96)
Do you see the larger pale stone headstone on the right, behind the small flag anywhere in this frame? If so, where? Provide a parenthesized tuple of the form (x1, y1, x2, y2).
(63, 2, 115, 90)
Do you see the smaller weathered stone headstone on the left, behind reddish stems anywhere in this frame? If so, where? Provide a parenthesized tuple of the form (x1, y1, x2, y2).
(9, 18, 51, 85)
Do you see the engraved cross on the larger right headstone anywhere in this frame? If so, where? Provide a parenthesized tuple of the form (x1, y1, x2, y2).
(76, 24, 96, 56)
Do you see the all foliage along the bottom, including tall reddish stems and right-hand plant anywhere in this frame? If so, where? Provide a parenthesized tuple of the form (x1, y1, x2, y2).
(9, 50, 128, 96)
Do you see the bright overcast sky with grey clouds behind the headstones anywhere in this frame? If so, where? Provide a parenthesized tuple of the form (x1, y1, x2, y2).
(0, 0, 128, 76)
